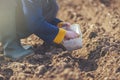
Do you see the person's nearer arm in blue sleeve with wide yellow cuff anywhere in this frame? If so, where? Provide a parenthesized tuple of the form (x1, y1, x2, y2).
(22, 0, 66, 44)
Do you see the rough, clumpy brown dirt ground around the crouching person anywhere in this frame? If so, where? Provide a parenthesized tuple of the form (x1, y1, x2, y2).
(0, 0, 120, 80)
